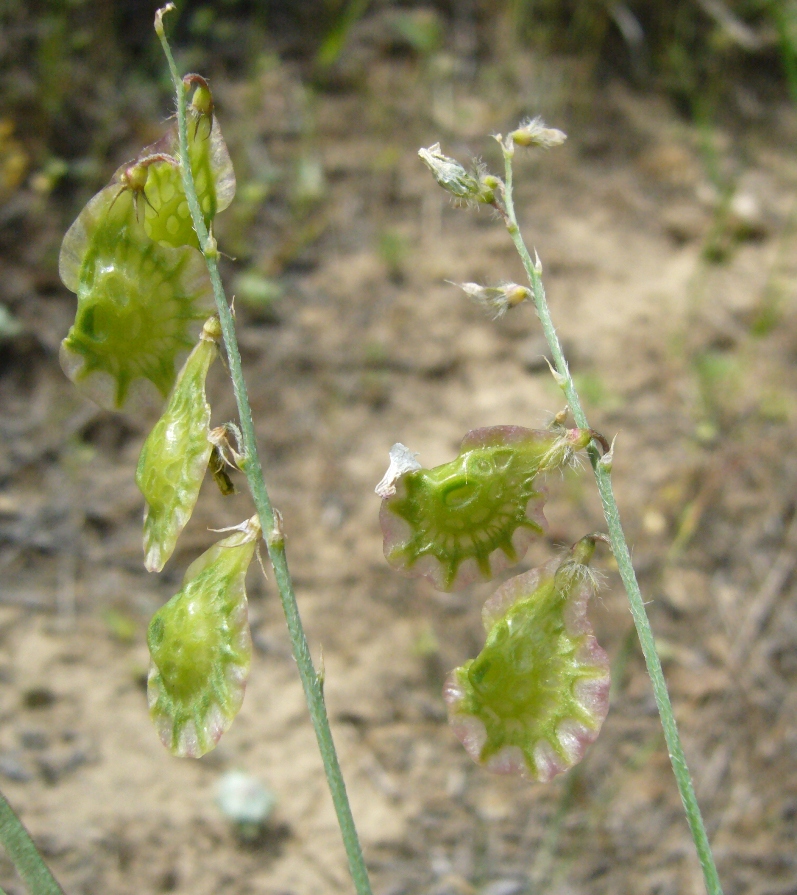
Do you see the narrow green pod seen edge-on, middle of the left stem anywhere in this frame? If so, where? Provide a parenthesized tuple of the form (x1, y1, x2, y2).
(136, 317, 221, 572)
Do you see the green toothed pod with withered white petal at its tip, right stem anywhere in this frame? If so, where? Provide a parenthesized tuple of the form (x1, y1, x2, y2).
(379, 426, 590, 591)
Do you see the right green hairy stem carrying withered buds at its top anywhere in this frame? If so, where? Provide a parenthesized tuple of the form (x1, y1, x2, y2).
(502, 144, 722, 895)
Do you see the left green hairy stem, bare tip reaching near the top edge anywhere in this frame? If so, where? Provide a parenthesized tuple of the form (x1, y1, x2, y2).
(155, 11, 371, 895)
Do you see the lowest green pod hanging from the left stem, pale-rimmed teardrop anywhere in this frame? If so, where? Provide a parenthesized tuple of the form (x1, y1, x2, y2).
(147, 516, 260, 758)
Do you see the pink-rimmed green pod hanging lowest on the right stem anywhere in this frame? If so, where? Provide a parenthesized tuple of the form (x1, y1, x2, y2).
(443, 538, 609, 782)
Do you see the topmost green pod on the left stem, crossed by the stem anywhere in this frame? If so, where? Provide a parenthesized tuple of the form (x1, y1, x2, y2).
(139, 113, 235, 248)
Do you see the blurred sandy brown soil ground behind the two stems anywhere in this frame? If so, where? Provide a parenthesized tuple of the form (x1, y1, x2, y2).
(0, 33, 797, 895)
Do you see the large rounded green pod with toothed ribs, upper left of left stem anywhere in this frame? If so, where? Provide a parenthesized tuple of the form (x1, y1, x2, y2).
(59, 191, 212, 410)
